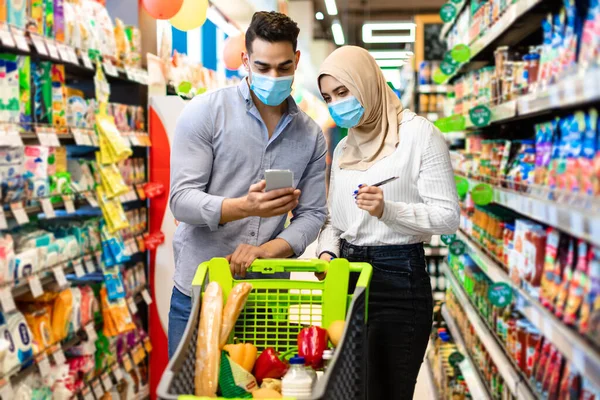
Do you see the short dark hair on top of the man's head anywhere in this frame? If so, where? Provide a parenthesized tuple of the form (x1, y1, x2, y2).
(246, 11, 300, 53)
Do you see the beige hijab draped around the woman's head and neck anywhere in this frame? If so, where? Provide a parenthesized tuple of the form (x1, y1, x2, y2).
(319, 46, 402, 171)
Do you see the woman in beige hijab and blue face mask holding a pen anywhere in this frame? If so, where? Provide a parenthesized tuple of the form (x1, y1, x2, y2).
(317, 46, 459, 400)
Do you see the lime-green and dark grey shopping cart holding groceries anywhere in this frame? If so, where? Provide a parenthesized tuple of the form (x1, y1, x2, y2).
(157, 258, 373, 400)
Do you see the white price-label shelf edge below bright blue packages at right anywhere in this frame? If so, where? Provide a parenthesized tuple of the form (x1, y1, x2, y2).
(460, 174, 600, 246)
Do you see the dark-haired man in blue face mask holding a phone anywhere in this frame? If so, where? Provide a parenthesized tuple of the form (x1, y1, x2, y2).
(169, 12, 327, 357)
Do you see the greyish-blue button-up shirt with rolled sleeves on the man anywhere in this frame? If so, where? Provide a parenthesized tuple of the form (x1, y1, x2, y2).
(170, 79, 327, 296)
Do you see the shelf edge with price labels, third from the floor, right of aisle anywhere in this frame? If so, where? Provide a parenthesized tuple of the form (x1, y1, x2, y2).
(457, 232, 600, 382)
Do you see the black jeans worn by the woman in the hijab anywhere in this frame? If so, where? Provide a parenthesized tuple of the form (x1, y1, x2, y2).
(341, 241, 433, 400)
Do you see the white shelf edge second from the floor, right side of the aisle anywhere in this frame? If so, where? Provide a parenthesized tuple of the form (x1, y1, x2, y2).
(443, 265, 536, 400)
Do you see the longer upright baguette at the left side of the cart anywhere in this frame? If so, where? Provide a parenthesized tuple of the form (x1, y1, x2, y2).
(195, 282, 223, 397)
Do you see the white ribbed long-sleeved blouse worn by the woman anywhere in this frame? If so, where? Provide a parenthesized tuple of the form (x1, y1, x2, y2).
(317, 110, 460, 257)
